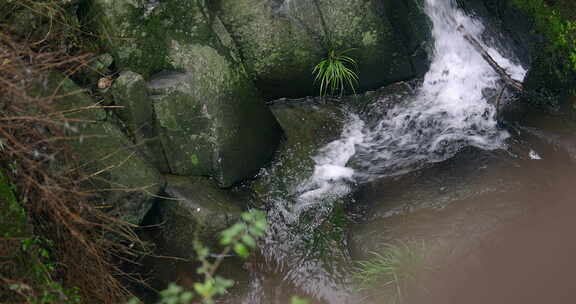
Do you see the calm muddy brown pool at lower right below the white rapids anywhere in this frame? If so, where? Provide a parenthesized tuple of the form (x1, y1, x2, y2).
(352, 114, 576, 304)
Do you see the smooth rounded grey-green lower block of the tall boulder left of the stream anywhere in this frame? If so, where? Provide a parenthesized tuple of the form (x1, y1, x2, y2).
(148, 63, 282, 187)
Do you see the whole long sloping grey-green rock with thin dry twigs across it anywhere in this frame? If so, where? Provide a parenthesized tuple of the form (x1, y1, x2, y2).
(42, 74, 164, 224)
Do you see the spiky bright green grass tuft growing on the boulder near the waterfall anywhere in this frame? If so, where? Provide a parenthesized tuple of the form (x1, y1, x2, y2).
(312, 49, 358, 96)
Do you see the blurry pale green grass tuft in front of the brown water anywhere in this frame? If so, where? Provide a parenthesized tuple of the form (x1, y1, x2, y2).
(353, 241, 426, 303)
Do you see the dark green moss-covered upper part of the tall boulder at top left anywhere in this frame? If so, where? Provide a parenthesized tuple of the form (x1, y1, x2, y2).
(84, 0, 237, 78)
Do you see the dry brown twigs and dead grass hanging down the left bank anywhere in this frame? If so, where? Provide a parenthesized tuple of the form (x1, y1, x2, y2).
(0, 1, 148, 303)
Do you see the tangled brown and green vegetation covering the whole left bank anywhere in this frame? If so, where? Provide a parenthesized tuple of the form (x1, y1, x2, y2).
(0, 0, 142, 303)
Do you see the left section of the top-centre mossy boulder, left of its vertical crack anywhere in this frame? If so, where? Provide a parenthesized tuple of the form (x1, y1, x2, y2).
(215, 0, 324, 97)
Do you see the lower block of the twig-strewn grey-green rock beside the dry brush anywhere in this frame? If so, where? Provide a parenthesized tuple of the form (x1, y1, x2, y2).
(72, 122, 164, 224)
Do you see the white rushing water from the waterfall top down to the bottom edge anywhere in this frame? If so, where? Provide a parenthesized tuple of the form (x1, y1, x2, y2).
(237, 0, 526, 304)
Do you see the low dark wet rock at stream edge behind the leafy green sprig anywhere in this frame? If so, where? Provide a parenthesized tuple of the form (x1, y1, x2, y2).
(138, 175, 250, 294)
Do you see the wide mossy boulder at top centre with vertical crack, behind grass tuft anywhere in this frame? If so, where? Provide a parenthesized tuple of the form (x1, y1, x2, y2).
(215, 0, 414, 98)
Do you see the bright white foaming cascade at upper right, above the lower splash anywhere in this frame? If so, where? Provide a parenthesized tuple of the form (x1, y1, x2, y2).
(300, 0, 526, 204)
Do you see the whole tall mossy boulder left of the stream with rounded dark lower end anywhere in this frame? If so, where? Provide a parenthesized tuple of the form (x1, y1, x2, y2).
(90, 0, 282, 187)
